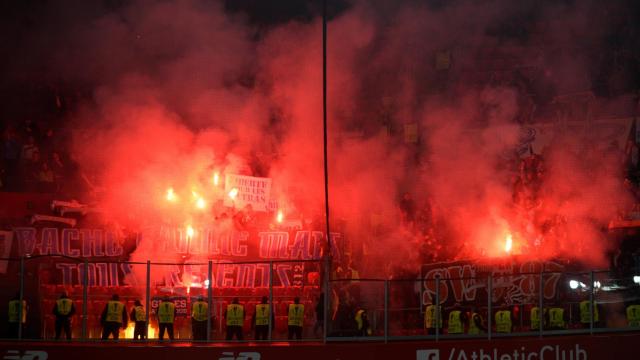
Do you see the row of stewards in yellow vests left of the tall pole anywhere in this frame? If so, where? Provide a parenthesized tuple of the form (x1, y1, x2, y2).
(8, 293, 305, 341)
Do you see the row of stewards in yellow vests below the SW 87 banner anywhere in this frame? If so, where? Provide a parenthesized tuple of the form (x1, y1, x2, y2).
(424, 300, 640, 335)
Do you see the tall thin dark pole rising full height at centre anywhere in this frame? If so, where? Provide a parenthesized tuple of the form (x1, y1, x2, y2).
(322, 0, 332, 342)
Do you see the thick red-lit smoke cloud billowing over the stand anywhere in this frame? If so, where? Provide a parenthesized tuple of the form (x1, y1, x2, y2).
(12, 0, 625, 275)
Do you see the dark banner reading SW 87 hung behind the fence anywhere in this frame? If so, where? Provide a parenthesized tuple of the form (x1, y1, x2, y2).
(421, 261, 565, 305)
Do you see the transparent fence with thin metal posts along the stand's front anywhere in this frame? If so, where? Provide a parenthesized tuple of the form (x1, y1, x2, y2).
(0, 256, 640, 342)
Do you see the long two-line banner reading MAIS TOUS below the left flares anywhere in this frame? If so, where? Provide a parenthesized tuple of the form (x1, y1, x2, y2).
(12, 225, 341, 288)
